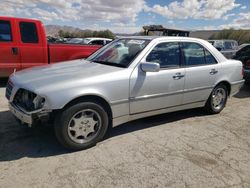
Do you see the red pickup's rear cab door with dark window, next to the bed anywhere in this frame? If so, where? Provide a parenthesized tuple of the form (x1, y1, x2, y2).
(17, 19, 48, 69)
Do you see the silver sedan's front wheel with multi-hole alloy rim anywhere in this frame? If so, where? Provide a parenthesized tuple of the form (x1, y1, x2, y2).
(55, 102, 109, 150)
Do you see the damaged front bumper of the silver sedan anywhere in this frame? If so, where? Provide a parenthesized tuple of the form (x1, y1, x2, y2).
(9, 103, 51, 127)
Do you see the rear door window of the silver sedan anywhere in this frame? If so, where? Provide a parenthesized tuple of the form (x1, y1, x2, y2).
(182, 43, 217, 66)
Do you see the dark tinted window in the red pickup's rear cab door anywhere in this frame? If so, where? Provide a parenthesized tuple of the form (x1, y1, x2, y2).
(19, 22, 38, 43)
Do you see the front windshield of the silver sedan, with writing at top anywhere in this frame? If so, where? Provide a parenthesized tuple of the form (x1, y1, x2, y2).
(88, 39, 149, 67)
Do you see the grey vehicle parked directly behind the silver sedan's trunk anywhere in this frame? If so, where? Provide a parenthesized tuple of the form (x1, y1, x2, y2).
(208, 40, 239, 59)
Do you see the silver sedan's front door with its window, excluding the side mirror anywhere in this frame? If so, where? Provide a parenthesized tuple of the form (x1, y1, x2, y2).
(130, 42, 185, 114)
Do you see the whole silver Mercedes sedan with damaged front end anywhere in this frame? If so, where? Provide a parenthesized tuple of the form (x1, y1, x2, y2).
(6, 37, 244, 150)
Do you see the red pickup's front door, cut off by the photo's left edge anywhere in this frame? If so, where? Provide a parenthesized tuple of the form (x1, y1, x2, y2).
(0, 18, 21, 77)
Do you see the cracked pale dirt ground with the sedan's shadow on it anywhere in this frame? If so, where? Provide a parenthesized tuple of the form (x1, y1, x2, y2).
(0, 79, 250, 188)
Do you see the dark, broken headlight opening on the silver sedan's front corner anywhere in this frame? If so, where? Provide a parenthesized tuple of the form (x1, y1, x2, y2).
(13, 89, 45, 112)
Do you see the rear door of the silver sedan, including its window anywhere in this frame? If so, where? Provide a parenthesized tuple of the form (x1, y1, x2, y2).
(182, 42, 221, 104)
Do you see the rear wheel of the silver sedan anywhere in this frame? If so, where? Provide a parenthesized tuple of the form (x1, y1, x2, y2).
(205, 84, 228, 114)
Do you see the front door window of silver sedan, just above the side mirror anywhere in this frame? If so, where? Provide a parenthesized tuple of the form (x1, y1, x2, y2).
(146, 42, 181, 68)
